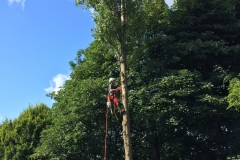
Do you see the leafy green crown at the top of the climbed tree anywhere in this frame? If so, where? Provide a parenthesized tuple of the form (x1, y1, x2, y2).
(76, 0, 146, 54)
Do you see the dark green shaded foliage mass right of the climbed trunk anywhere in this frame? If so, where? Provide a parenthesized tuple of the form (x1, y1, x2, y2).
(129, 0, 240, 159)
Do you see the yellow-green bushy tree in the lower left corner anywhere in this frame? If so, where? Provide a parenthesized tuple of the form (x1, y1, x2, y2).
(0, 104, 50, 160)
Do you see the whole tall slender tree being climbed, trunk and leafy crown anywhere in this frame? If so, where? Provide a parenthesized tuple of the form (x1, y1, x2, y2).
(76, 0, 144, 160)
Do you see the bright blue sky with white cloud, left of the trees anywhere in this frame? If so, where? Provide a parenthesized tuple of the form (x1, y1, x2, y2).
(0, 0, 173, 122)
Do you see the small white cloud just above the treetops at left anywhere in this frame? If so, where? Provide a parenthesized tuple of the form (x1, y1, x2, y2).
(45, 74, 70, 93)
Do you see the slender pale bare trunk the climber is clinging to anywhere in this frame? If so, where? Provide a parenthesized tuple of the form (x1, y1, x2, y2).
(120, 0, 132, 160)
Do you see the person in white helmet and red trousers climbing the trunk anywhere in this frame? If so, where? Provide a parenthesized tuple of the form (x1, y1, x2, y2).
(107, 78, 125, 113)
